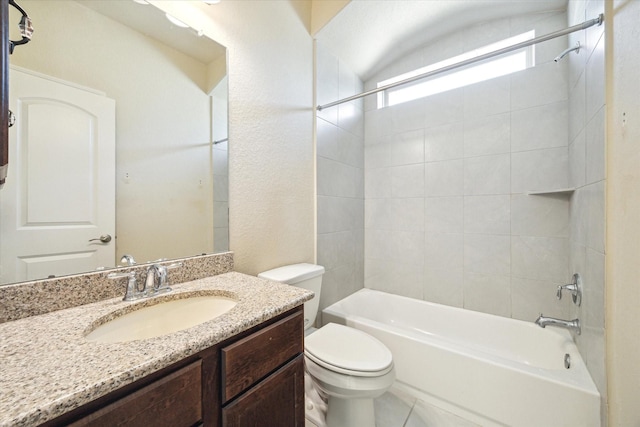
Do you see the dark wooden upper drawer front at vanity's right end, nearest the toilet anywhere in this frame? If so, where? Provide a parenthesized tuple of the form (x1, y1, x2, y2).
(222, 310, 304, 403)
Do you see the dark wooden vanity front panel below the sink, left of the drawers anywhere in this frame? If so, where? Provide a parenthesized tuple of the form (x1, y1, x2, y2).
(70, 360, 202, 427)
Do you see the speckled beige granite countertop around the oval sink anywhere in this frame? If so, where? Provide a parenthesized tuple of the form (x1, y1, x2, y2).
(0, 272, 313, 426)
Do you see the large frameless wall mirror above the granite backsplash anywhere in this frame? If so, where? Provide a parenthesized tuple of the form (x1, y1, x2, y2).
(0, 0, 228, 284)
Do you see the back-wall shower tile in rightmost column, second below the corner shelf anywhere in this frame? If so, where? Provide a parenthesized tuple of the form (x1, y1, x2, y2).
(511, 236, 569, 281)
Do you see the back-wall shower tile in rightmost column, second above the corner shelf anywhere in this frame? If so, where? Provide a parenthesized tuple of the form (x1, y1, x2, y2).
(511, 101, 568, 152)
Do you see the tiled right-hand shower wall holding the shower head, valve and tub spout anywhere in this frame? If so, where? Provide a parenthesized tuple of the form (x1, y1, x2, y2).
(567, 0, 607, 416)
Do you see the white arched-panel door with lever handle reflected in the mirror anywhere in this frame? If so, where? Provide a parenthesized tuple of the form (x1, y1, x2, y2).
(0, 68, 115, 283)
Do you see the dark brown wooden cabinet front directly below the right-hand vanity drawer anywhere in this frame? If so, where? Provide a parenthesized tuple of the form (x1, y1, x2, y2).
(222, 355, 304, 427)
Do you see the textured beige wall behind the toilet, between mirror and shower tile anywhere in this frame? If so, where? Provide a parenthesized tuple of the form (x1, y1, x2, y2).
(153, 1, 315, 274)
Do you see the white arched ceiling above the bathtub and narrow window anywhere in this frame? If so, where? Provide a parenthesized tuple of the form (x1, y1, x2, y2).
(316, 0, 567, 81)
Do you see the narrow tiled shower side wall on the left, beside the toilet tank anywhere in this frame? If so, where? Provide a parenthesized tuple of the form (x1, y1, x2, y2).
(316, 45, 364, 324)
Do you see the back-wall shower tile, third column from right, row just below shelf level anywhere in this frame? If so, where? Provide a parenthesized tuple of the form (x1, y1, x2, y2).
(424, 196, 463, 233)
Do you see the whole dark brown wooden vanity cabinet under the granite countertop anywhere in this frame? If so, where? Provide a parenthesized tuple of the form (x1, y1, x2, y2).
(43, 306, 304, 427)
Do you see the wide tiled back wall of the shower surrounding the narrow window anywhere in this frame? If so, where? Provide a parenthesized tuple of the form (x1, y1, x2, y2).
(365, 12, 571, 321)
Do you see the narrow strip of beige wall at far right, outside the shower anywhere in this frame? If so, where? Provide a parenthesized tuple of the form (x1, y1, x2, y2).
(605, 0, 640, 427)
